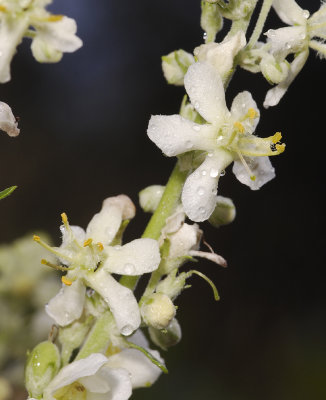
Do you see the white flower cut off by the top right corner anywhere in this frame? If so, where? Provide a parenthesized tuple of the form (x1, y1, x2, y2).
(264, 0, 326, 108)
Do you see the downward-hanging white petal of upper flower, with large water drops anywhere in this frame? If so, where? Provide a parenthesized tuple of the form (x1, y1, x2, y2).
(181, 150, 233, 222)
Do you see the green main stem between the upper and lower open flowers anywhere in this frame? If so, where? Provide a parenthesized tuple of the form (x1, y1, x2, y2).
(120, 163, 188, 290)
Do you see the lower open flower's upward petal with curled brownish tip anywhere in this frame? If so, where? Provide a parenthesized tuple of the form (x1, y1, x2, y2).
(86, 194, 135, 244)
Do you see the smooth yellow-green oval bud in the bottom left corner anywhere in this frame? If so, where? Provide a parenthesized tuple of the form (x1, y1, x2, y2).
(25, 341, 60, 399)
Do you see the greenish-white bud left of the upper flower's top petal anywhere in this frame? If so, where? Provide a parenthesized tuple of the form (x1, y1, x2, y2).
(162, 50, 195, 86)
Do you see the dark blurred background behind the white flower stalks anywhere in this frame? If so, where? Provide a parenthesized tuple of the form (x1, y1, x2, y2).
(0, 0, 326, 400)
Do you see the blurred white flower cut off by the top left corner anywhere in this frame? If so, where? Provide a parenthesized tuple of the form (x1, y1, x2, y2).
(0, 0, 82, 83)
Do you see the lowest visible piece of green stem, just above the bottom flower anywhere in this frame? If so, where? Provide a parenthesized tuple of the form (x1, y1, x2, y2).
(76, 311, 113, 360)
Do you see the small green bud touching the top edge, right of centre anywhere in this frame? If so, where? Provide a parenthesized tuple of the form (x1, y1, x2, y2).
(200, 1, 223, 43)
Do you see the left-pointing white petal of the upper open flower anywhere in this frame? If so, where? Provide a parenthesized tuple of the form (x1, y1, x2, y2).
(147, 115, 215, 157)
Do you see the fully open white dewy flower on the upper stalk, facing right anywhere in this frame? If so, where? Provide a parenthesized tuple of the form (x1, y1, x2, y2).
(147, 62, 285, 222)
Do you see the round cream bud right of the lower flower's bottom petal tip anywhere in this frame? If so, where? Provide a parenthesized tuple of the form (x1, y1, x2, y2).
(140, 293, 175, 329)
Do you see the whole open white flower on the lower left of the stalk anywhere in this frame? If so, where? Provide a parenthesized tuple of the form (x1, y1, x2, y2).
(34, 195, 160, 335)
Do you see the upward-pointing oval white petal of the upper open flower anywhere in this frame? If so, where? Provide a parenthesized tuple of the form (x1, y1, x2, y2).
(184, 62, 228, 124)
